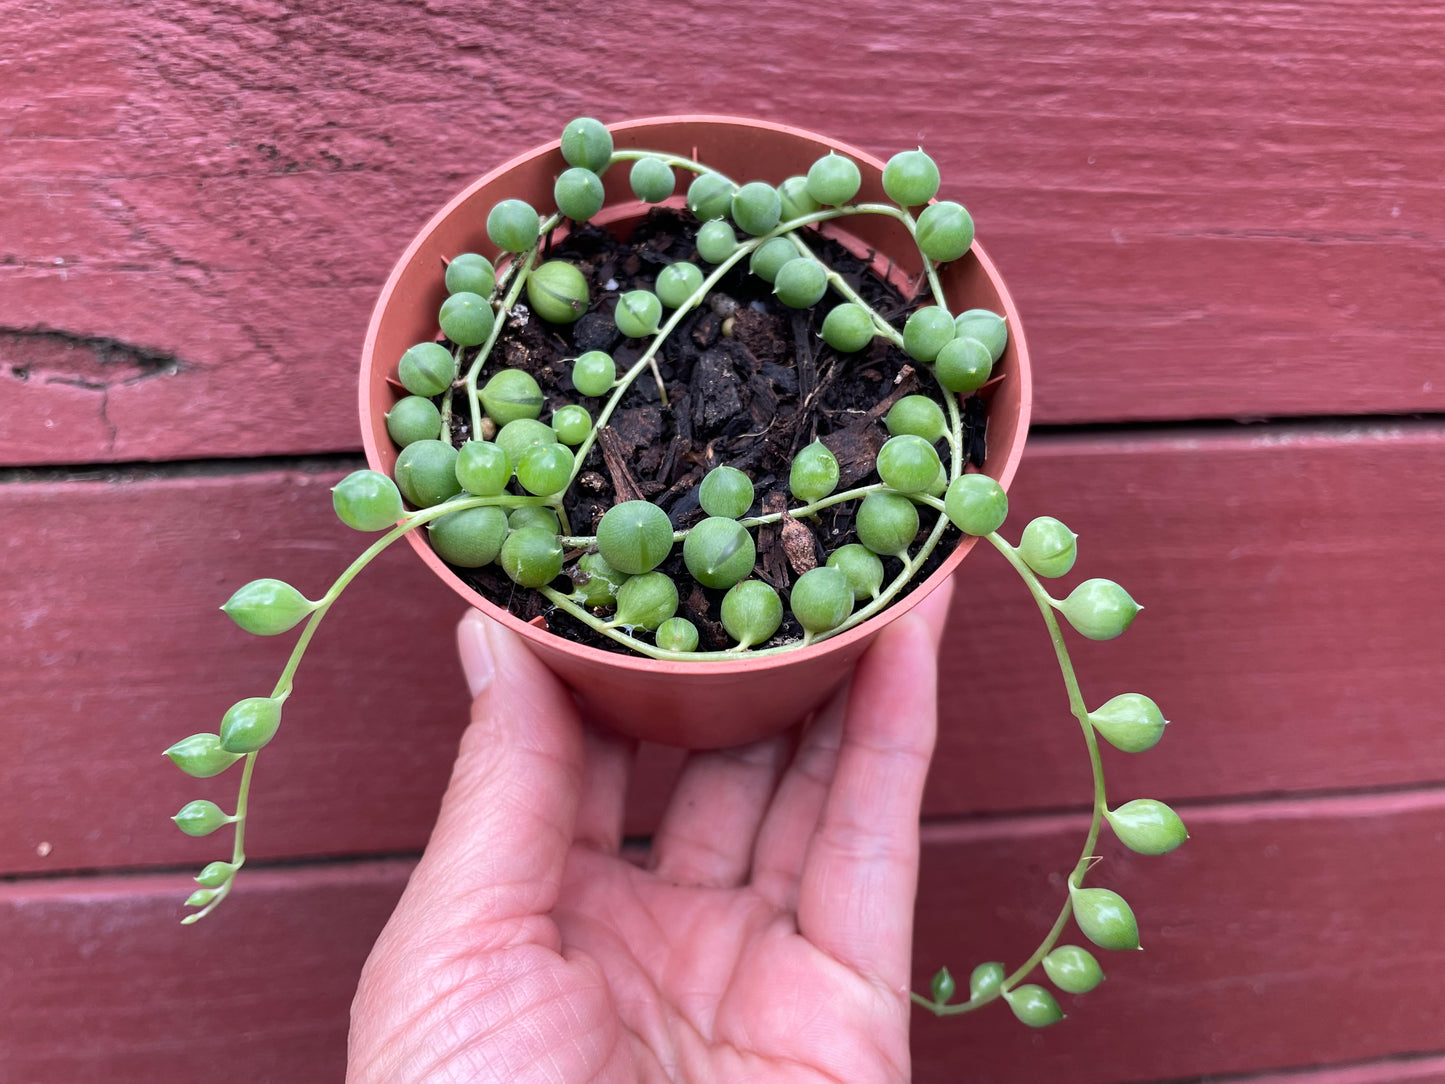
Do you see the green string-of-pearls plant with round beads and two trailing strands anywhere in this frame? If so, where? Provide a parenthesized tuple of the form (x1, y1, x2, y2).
(166, 119, 1186, 1026)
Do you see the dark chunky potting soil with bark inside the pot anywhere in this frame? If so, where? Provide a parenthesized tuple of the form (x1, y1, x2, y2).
(433, 208, 985, 652)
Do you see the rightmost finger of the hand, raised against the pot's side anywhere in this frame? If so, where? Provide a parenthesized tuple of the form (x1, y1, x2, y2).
(798, 604, 938, 993)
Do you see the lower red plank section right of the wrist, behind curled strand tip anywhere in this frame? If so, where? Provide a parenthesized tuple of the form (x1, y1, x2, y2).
(913, 789, 1445, 1084)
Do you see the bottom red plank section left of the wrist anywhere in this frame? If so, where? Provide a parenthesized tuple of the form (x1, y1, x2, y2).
(0, 861, 410, 1084)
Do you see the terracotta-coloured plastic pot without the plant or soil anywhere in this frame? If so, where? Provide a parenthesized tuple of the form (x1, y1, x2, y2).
(360, 116, 1032, 749)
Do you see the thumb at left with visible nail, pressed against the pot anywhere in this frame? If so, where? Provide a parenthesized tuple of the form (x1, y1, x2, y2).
(397, 611, 584, 925)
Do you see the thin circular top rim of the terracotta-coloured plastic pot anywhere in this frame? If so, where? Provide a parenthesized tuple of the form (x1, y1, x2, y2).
(358, 113, 1033, 676)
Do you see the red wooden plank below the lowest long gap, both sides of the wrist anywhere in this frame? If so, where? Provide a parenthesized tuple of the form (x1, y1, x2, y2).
(0, 791, 1445, 1084)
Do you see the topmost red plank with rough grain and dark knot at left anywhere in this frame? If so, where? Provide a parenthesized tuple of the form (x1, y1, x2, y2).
(0, 0, 1445, 464)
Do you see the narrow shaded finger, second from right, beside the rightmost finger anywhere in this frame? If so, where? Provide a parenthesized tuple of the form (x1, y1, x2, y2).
(751, 685, 848, 911)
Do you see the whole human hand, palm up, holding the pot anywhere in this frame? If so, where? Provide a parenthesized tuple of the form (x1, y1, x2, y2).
(347, 585, 951, 1084)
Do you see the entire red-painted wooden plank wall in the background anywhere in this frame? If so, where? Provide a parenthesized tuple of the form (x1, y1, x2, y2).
(0, 0, 1445, 1084)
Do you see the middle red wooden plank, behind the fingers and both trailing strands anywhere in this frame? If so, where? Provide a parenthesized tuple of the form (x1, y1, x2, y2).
(0, 425, 1445, 873)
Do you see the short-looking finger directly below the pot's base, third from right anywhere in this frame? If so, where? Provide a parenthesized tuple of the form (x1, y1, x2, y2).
(652, 734, 792, 887)
